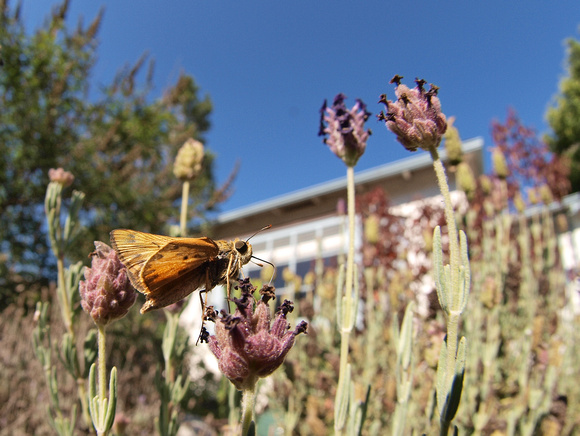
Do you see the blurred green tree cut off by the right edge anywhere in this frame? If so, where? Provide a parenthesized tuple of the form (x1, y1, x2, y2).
(545, 30, 580, 192)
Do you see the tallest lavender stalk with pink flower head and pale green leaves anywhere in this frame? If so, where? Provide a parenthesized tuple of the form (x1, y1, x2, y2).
(378, 75, 470, 435)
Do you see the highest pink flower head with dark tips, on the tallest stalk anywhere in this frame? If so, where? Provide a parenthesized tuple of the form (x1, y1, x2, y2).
(378, 75, 447, 151)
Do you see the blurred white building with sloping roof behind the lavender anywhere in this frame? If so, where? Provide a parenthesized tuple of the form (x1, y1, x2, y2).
(213, 137, 484, 292)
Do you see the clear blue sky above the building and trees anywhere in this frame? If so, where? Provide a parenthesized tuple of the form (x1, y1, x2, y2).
(20, 0, 580, 211)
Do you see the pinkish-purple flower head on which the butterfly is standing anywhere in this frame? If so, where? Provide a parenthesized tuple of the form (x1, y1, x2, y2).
(207, 279, 308, 390)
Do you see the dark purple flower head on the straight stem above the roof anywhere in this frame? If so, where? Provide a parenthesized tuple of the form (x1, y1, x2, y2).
(318, 94, 371, 167)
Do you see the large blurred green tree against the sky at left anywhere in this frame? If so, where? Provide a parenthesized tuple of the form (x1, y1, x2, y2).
(0, 0, 233, 307)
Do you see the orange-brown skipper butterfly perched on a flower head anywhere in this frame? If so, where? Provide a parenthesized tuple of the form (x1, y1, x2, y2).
(111, 226, 271, 313)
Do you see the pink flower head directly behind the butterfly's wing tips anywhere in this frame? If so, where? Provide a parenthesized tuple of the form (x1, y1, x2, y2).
(79, 241, 137, 326)
